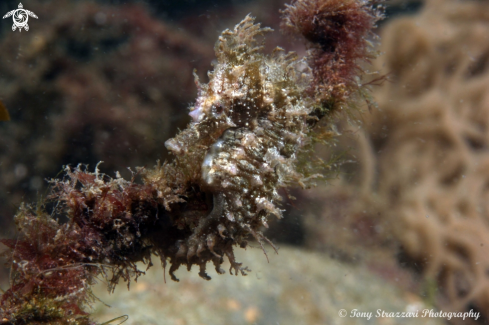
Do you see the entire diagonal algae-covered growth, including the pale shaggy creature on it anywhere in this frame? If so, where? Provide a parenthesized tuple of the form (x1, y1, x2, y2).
(0, 0, 382, 324)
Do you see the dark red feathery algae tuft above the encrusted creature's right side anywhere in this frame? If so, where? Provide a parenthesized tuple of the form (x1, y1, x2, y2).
(282, 0, 383, 109)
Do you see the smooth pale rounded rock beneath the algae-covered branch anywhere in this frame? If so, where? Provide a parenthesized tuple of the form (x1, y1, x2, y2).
(93, 246, 444, 325)
